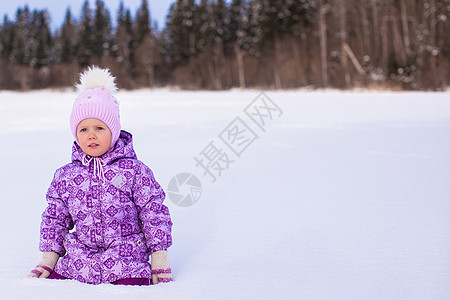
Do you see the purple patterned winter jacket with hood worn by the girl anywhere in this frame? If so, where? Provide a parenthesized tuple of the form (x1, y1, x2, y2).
(39, 131, 172, 284)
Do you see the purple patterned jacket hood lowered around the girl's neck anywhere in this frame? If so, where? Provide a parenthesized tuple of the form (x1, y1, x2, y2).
(72, 130, 137, 164)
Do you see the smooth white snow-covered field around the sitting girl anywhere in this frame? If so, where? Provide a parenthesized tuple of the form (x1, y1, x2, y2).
(0, 90, 450, 300)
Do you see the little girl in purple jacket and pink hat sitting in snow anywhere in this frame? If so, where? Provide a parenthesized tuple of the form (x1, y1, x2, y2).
(30, 67, 172, 285)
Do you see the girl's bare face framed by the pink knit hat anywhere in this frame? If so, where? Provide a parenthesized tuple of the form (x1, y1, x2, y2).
(77, 118, 112, 157)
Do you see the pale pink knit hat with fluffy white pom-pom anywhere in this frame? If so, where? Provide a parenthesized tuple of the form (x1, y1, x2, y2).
(70, 66, 121, 148)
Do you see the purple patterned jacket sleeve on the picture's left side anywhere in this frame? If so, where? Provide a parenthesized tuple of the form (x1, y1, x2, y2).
(39, 169, 73, 256)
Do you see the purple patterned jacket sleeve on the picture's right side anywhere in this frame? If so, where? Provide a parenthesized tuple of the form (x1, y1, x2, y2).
(133, 163, 172, 253)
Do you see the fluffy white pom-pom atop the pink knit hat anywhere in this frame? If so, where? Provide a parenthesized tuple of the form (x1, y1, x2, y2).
(76, 66, 117, 94)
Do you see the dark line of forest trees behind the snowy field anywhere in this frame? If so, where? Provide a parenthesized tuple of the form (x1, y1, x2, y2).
(0, 0, 450, 90)
